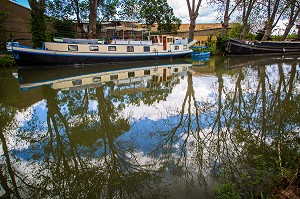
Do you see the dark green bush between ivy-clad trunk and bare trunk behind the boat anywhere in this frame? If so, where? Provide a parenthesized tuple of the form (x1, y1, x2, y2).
(51, 17, 76, 38)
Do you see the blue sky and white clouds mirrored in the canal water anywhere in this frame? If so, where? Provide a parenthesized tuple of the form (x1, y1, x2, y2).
(0, 63, 299, 199)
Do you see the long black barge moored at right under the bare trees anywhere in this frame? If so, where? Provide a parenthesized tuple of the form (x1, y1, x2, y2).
(225, 39, 300, 55)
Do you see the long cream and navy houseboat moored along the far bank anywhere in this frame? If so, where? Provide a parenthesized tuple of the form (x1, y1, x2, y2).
(13, 35, 196, 66)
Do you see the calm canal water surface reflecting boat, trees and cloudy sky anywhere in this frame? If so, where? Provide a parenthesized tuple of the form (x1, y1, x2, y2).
(0, 56, 300, 199)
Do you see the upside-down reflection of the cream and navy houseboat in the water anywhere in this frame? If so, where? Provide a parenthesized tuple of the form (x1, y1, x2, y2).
(18, 60, 191, 91)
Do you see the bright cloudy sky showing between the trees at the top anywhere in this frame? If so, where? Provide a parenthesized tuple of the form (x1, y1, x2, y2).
(16, 0, 217, 23)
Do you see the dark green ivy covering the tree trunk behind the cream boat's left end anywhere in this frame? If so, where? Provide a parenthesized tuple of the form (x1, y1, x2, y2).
(31, 10, 46, 48)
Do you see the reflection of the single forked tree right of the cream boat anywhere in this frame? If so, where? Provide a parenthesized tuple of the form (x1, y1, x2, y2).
(149, 70, 209, 197)
